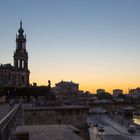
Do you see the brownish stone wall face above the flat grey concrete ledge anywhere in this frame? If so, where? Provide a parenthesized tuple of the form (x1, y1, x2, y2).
(24, 107, 88, 128)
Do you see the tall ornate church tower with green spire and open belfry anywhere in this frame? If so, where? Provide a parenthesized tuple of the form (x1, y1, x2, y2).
(13, 21, 30, 86)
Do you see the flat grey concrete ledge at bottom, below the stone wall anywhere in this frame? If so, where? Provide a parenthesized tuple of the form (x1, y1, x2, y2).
(15, 125, 84, 140)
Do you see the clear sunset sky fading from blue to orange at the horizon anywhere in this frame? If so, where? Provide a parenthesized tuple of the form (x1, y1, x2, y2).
(0, 0, 140, 93)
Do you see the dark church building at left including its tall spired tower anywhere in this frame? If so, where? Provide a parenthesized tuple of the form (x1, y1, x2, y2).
(0, 21, 30, 87)
